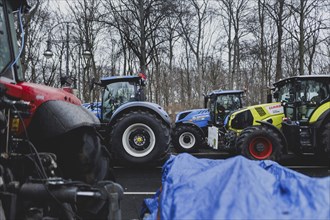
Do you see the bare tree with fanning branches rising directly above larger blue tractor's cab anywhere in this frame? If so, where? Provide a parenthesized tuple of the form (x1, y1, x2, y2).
(101, 0, 170, 73)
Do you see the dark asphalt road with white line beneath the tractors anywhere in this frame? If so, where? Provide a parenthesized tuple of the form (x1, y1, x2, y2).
(114, 150, 330, 220)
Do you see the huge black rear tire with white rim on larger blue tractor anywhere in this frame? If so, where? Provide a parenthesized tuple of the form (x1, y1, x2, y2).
(109, 110, 170, 165)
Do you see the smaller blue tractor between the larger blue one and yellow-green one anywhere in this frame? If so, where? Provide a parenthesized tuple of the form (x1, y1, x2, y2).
(172, 90, 244, 153)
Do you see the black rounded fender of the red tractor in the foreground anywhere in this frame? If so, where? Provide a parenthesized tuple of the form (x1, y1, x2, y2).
(28, 100, 100, 141)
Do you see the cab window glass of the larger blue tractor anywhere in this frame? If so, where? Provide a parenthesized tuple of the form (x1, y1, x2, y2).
(102, 82, 137, 120)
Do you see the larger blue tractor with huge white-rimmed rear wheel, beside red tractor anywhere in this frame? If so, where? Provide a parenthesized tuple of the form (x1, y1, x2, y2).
(87, 74, 171, 165)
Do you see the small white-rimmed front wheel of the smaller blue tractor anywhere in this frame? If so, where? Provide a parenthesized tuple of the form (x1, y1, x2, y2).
(172, 125, 203, 153)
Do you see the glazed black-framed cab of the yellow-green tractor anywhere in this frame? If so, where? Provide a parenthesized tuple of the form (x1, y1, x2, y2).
(274, 75, 330, 123)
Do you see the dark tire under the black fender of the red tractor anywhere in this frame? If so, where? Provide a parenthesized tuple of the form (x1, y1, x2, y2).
(43, 127, 112, 184)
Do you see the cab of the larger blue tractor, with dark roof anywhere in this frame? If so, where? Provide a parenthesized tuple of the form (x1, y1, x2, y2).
(100, 75, 146, 122)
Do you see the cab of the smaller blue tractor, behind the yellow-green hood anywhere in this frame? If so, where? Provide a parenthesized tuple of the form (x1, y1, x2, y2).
(209, 90, 244, 127)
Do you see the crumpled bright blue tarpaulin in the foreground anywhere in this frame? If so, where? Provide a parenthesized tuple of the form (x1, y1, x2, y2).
(144, 153, 330, 220)
